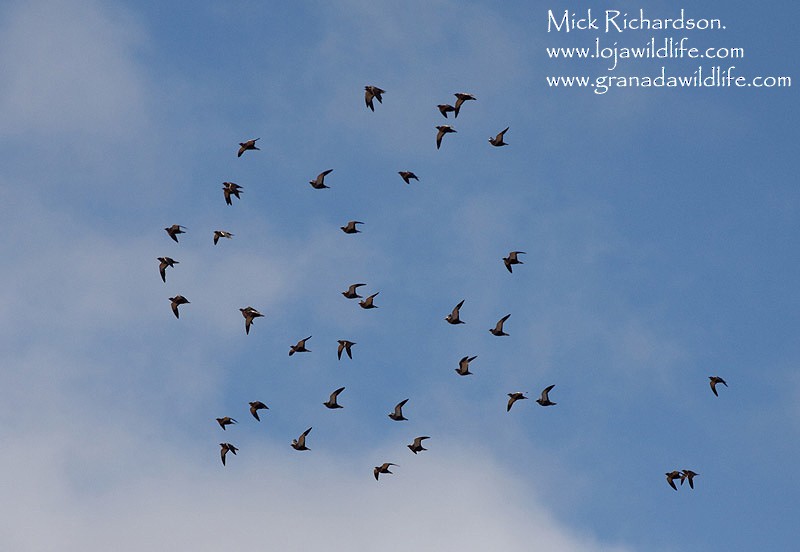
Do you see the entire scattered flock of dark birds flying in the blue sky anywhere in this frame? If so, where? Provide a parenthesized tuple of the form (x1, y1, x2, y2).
(158, 85, 728, 491)
